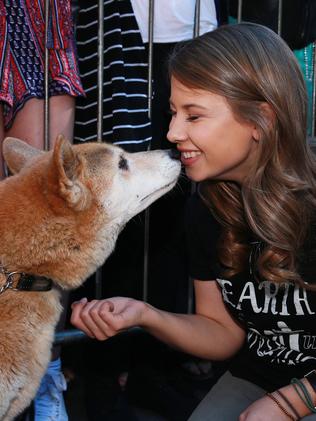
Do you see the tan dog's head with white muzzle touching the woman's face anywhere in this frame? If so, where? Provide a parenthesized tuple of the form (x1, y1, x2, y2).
(0, 136, 180, 286)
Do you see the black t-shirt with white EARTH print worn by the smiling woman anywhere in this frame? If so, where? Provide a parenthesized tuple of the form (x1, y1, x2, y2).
(186, 194, 316, 391)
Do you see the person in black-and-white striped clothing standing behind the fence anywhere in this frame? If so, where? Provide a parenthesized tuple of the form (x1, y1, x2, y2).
(74, 0, 151, 152)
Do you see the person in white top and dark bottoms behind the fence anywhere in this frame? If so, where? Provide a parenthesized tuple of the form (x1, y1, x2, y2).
(131, 0, 217, 149)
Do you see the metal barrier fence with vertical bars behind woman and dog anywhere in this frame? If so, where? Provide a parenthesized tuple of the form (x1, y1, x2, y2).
(53, 0, 316, 344)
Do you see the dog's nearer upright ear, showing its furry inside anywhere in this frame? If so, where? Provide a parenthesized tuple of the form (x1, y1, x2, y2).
(53, 135, 91, 211)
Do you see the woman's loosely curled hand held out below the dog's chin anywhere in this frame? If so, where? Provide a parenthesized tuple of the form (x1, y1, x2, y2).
(70, 297, 146, 341)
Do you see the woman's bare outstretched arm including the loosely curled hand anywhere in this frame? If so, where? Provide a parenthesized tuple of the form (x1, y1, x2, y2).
(71, 281, 245, 360)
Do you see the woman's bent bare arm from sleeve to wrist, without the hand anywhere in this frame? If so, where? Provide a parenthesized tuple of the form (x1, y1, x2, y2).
(143, 280, 245, 360)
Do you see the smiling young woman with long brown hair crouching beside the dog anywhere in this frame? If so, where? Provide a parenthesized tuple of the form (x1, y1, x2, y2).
(72, 24, 316, 421)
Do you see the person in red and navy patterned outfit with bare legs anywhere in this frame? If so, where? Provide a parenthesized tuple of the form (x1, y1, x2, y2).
(0, 0, 84, 177)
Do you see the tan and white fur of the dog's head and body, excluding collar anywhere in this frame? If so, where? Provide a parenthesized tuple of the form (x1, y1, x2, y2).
(0, 136, 180, 421)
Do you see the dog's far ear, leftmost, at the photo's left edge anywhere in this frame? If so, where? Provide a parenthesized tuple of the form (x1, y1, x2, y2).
(2, 137, 43, 174)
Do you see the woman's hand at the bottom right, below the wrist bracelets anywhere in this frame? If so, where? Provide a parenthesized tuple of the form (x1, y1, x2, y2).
(238, 396, 292, 421)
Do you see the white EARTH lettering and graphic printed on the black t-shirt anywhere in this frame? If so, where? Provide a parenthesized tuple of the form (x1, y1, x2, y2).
(217, 279, 316, 366)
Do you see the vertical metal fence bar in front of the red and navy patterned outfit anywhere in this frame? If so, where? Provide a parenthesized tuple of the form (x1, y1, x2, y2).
(44, 0, 50, 151)
